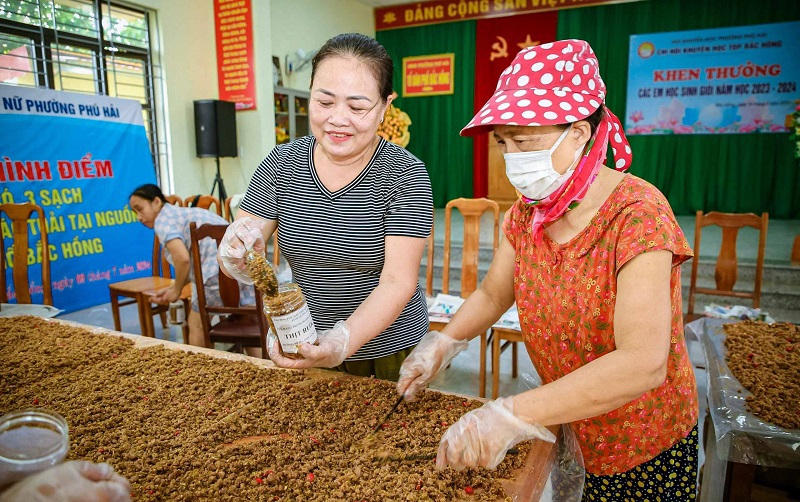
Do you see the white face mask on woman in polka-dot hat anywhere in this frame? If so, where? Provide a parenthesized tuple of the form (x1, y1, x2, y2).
(503, 124, 583, 200)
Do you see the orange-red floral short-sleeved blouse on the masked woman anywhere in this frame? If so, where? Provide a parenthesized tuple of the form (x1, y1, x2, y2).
(503, 174, 698, 475)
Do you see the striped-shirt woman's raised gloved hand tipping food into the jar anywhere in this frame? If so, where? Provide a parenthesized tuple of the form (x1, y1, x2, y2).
(217, 216, 267, 284)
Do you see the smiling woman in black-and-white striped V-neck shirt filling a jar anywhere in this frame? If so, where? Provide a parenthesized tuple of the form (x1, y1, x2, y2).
(219, 34, 433, 380)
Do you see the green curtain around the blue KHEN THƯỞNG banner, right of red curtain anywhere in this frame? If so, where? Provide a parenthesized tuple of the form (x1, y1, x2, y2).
(557, 0, 800, 219)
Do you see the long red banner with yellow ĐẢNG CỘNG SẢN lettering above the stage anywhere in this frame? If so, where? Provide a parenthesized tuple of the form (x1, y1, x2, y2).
(375, 0, 640, 31)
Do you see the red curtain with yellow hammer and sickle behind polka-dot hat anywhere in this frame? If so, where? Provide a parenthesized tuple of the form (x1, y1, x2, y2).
(472, 11, 558, 197)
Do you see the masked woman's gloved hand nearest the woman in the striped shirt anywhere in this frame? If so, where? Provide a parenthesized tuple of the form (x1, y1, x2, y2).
(397, 331, 469, 401)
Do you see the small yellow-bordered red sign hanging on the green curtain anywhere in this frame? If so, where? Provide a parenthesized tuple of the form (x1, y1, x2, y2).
(403, 54, 455, 97)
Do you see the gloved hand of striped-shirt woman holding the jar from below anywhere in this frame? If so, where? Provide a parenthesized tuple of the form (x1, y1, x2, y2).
(267, 321, 350, 368)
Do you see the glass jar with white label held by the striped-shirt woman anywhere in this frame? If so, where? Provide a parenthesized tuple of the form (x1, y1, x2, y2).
(263, 282, 317, 358)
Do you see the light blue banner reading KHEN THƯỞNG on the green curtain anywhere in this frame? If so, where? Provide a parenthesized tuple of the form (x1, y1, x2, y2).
(625, 22, 800, 135)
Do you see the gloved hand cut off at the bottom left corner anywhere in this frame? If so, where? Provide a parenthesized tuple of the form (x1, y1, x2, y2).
(0, 460, 131, 502)
